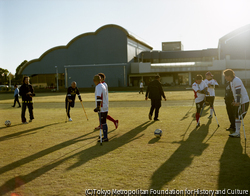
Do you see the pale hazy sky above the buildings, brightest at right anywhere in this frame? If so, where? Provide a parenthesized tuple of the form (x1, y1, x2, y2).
(0, 0, 250, 74)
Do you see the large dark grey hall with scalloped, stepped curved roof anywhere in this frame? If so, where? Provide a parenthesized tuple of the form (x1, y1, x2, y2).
(19, 24, 152, 87)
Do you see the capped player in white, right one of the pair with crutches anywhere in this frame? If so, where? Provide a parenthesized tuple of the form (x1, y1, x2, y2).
(204, 71, 219, 119)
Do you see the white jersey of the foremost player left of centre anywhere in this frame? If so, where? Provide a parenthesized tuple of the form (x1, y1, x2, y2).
(95, 83, 109, 112)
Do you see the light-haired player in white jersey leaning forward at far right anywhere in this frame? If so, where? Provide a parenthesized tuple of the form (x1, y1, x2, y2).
(223, 69, 249, 137)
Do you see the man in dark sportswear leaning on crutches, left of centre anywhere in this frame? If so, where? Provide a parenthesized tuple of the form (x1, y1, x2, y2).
(65, 81, 82, 121)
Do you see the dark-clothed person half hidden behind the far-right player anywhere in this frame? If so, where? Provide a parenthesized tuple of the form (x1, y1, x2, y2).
(224, 82, 235, 131)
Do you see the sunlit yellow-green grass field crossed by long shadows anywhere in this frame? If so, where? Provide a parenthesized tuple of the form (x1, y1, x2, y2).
(0, 91, 250, 196)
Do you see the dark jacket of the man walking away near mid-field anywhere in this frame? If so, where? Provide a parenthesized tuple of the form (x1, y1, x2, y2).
(146, 80, 166, 100)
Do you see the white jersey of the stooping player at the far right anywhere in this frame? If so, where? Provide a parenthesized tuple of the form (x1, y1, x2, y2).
(230, 77, 249, 104)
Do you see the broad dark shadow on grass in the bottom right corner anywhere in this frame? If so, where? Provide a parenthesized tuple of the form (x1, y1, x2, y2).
(218, 137, 250, 190)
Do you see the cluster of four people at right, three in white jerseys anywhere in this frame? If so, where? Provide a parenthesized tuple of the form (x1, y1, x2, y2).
(192, 69, 249, 137)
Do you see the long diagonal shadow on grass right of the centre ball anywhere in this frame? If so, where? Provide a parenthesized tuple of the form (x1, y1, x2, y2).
(150, 119, 211, 190)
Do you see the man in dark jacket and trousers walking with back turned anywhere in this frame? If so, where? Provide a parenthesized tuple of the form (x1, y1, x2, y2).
(145, 75, 167, 121)
